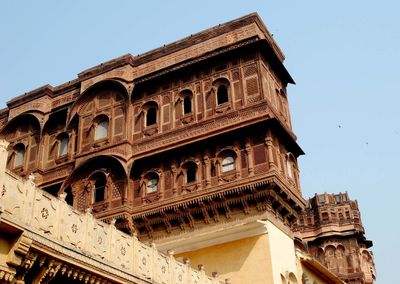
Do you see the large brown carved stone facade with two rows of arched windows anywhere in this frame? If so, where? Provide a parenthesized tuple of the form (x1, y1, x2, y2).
(0, 14, 374, 283)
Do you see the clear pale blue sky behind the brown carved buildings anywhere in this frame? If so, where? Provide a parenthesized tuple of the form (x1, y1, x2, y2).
(0, 0, 400, 283)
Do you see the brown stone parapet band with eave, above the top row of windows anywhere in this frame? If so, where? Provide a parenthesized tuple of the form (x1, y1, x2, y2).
(2, 14, 293, 123)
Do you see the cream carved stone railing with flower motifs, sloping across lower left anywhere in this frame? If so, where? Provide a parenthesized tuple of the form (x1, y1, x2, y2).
(0, 140, 220, 284)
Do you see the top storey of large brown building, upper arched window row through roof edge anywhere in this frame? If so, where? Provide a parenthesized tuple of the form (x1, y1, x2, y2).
(0, 14, 302, 173)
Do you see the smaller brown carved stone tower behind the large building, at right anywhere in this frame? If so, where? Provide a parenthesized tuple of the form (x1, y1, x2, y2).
(296, 193, 376, 284)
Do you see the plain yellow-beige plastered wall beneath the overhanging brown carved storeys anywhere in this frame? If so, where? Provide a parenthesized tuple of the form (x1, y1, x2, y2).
(176, 221, 297, 284)
